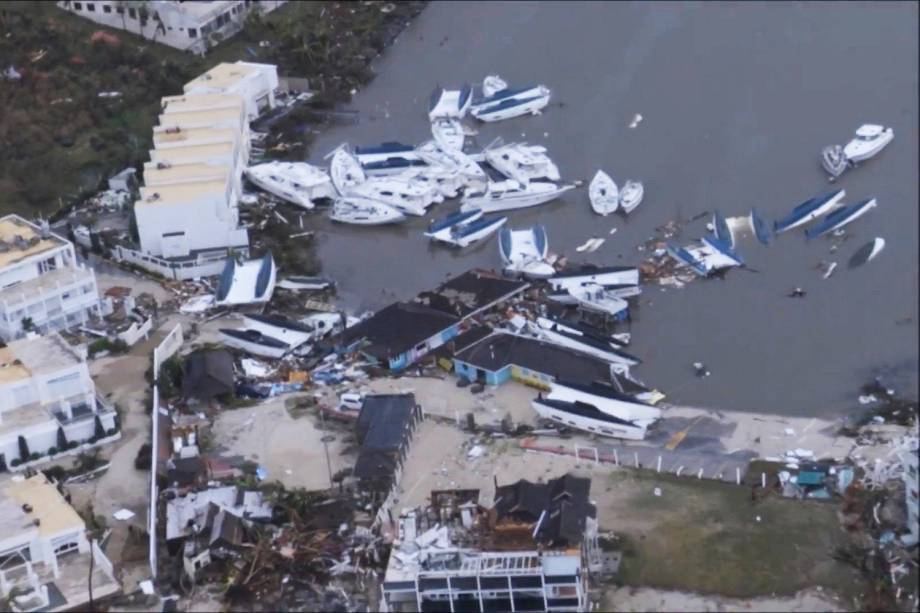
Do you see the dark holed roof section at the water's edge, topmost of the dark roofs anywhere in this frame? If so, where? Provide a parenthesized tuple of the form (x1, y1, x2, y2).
(415, 269, 530, 318)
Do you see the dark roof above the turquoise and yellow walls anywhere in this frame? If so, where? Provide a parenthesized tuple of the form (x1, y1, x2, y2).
(454, 332, 610, 383)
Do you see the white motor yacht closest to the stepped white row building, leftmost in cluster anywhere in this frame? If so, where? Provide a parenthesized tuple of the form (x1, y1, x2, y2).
(244, 161, 336, 209)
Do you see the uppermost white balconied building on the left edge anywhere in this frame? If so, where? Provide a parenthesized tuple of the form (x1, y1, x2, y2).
(0, 215, 99, 341)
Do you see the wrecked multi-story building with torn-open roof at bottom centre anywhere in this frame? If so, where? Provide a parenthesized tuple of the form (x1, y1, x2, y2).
(383, 475, 598, 611)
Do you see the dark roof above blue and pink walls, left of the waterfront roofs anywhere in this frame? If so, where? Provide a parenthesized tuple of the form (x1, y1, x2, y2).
(336, 302, 460, 360)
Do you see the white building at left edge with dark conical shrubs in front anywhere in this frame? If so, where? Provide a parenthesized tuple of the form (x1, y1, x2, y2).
(0, 332, 117, 469)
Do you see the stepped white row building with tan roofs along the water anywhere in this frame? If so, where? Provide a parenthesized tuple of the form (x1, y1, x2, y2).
(117, 62, 278, 279)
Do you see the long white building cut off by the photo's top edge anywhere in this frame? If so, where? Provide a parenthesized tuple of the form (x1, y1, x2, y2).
(57, 0, 285, 54)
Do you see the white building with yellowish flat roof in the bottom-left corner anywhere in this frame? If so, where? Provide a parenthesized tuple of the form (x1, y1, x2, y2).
(0, 473, 120, 611)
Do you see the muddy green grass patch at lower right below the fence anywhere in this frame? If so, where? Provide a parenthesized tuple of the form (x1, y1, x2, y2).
(600, 471, 860, 598)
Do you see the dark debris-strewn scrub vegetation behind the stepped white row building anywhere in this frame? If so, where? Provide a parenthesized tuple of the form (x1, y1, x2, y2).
(0, 2, 424, 215)
